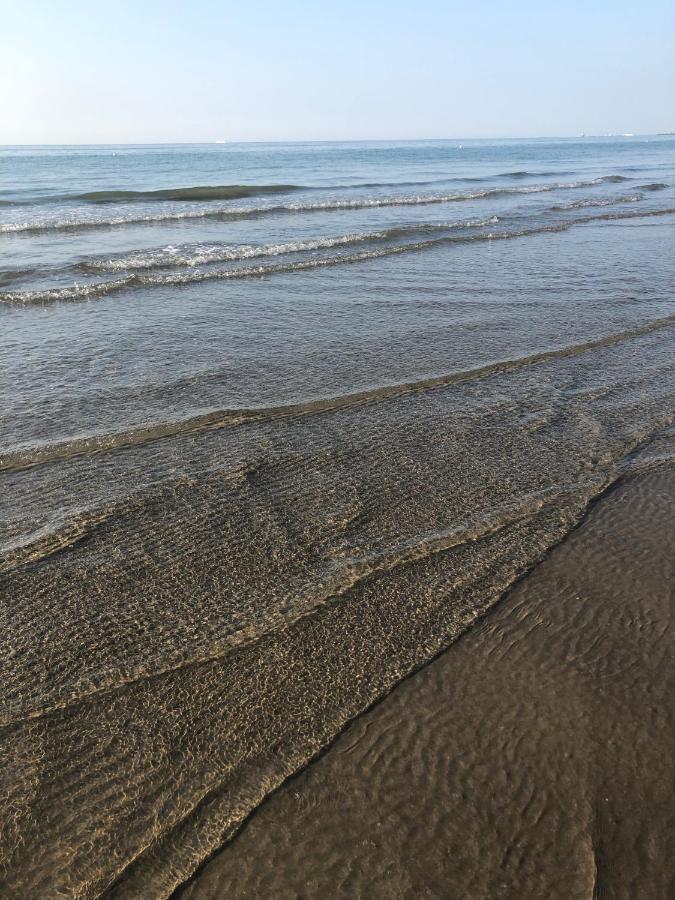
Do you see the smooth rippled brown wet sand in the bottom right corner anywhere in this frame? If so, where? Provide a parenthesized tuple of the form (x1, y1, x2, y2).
(179, 466, 675, 900)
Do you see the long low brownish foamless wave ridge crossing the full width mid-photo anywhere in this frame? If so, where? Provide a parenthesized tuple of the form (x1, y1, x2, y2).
(0, 314, 675, 471)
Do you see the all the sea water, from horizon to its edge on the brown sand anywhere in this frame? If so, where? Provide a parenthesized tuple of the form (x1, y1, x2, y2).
(0, 136, 675, 896)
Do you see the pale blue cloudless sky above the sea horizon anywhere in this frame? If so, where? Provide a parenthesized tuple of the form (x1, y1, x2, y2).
(0, 0, 675, 144)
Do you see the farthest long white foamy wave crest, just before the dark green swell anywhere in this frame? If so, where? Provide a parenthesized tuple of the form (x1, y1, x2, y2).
(0, 175, 622, 234)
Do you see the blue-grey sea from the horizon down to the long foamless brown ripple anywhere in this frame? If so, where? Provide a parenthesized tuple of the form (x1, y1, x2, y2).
(0, 138, 675, 458)
